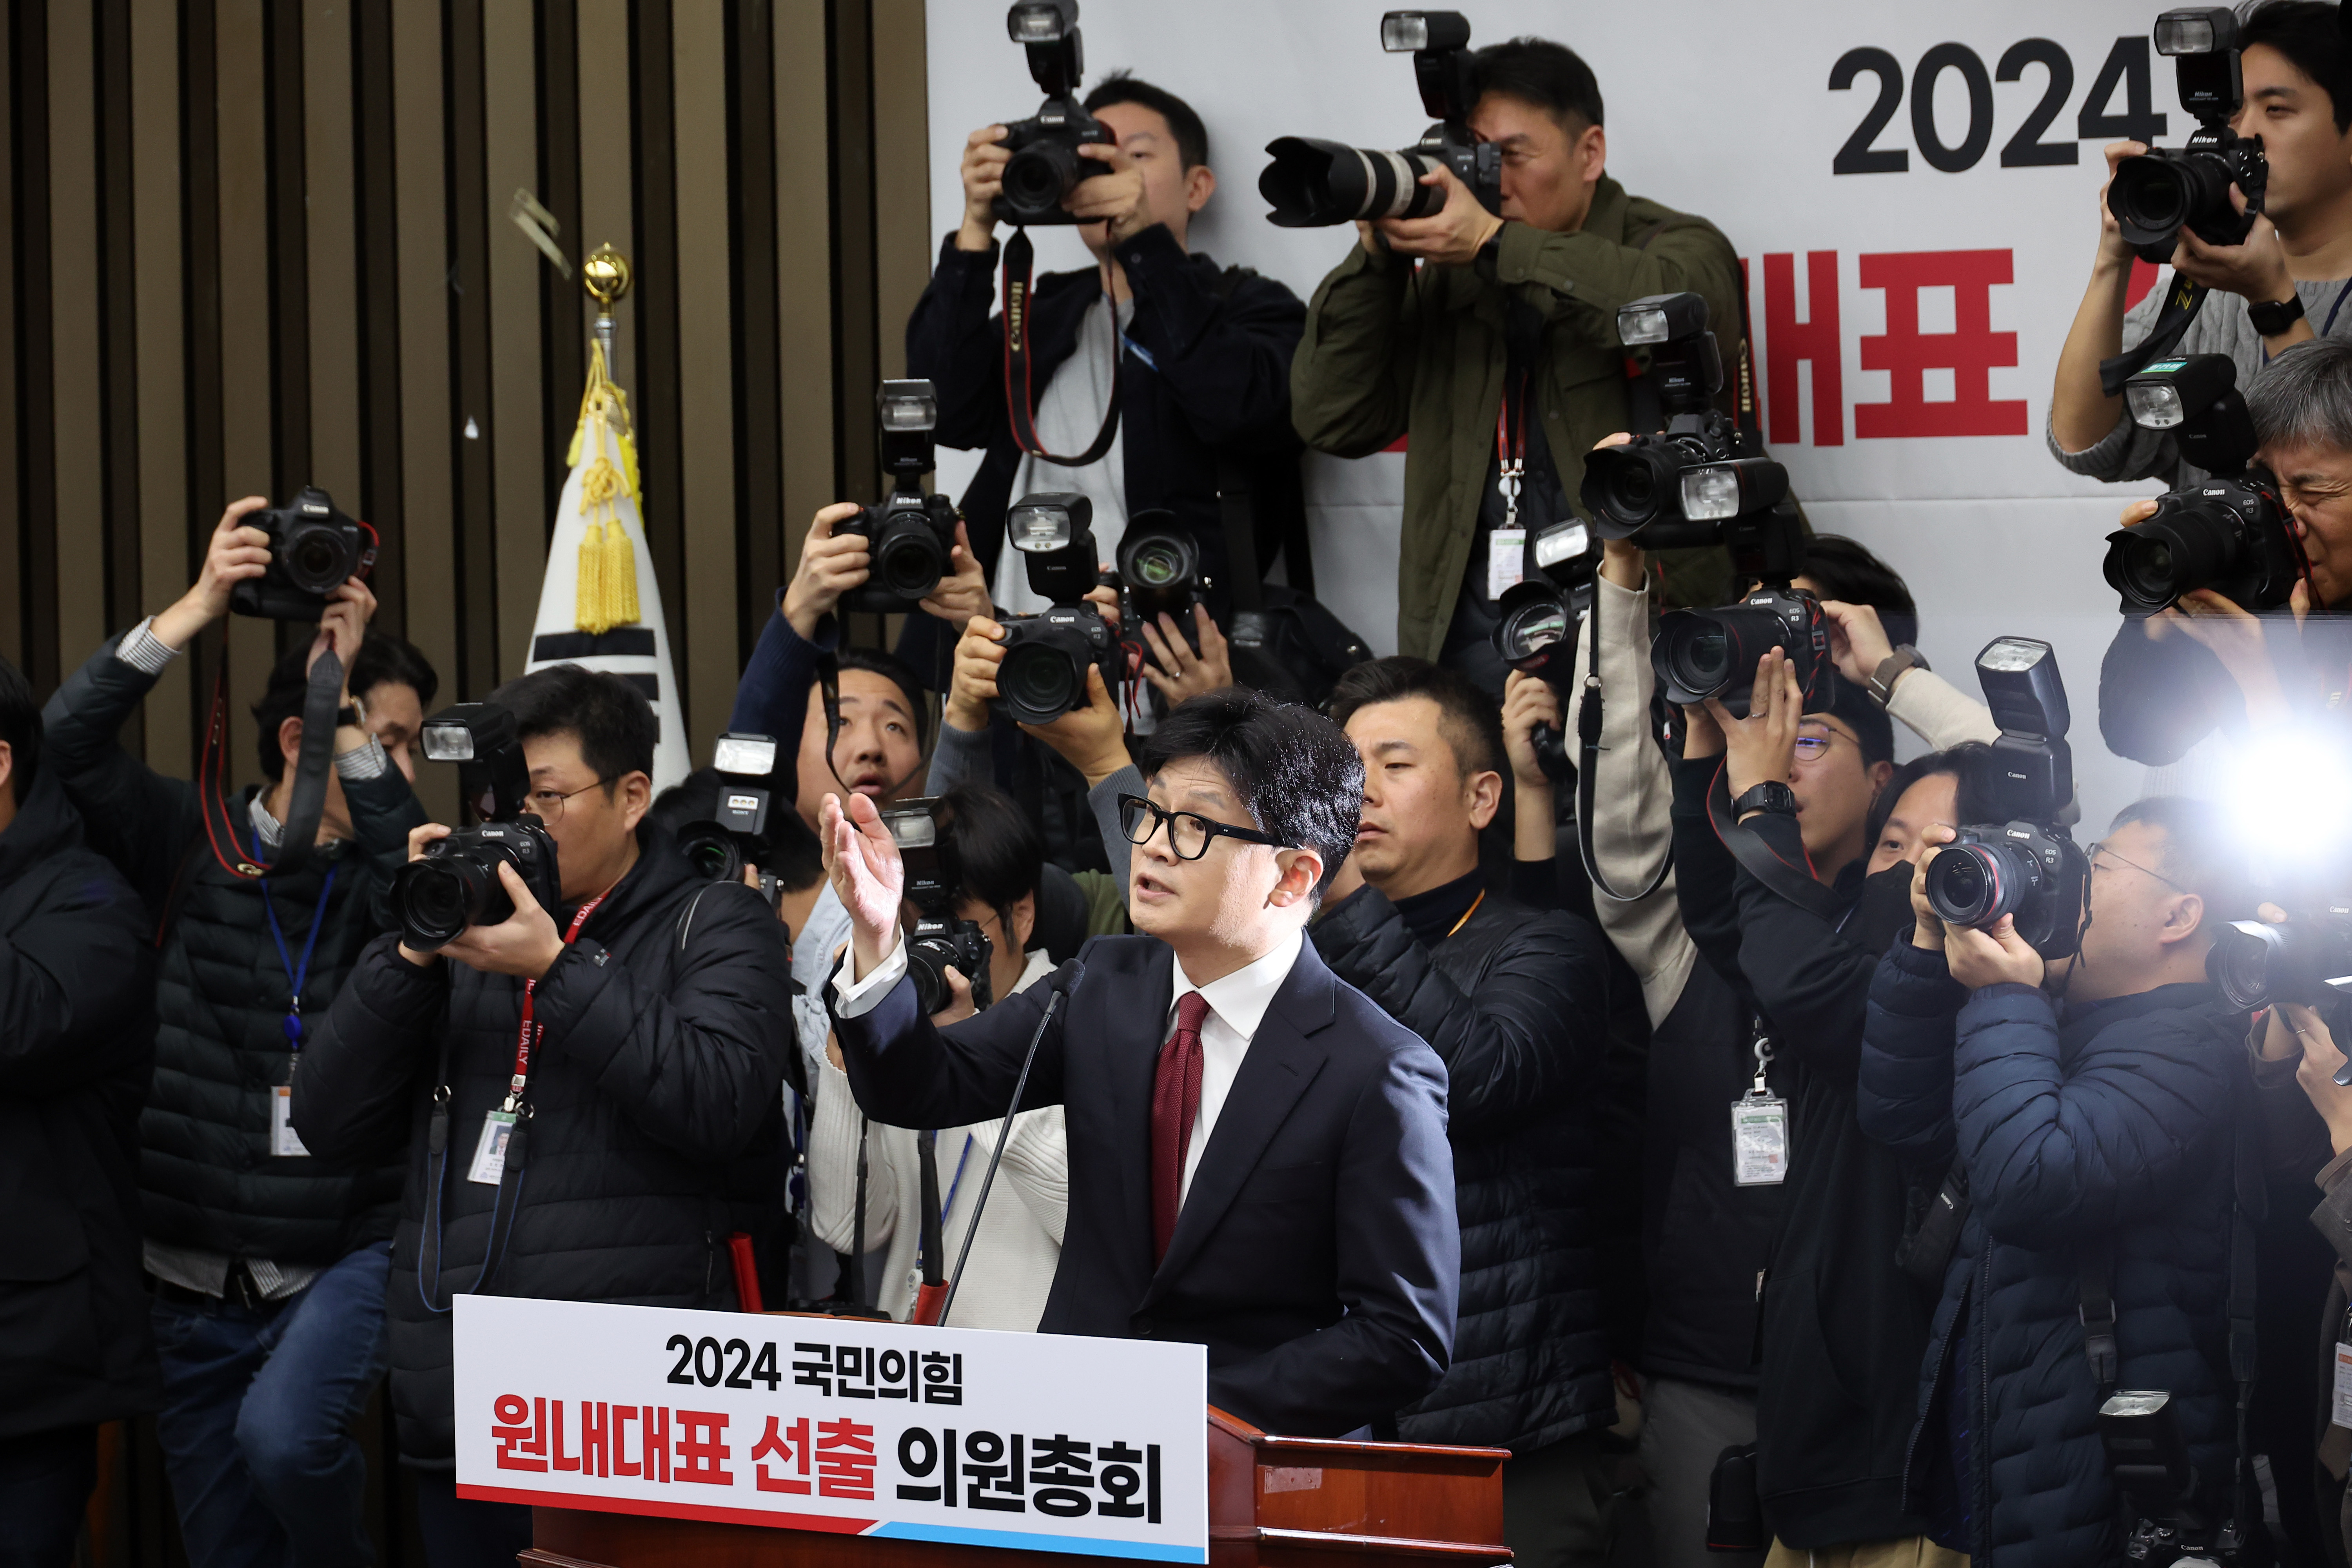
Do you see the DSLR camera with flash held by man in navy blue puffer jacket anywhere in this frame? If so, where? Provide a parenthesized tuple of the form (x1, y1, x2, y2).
(1926, 637, 2091, 959)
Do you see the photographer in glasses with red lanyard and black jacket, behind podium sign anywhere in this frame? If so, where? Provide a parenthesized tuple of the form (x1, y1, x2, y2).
(294, 665, 790, 1566)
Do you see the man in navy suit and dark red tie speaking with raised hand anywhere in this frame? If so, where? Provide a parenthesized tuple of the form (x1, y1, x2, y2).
(821, 691, 1461, 1436)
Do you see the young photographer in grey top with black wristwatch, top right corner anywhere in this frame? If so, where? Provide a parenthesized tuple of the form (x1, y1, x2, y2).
(2049, 0, 2352, 484)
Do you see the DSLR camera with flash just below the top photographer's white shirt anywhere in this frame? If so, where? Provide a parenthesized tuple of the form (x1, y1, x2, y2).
(997, 489, 1124, 724)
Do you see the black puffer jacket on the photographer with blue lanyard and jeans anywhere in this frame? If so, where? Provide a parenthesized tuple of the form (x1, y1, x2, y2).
(42, 642, 426, 1265)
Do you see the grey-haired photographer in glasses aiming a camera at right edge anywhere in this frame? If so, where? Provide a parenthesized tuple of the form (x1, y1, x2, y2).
(2098, 339, 2352, 766)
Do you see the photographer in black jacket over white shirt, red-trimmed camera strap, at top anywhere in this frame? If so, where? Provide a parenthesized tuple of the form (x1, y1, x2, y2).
(898, 63, 1303, 630)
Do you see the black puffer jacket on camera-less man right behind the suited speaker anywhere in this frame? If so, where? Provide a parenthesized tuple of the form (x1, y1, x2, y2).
(1312, 889, 1616, 1453)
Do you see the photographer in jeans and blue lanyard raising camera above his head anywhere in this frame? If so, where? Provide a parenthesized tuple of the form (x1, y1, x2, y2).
(42, 491, 437, 1568)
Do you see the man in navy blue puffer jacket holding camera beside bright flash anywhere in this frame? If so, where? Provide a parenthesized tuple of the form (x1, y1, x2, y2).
(1860, 797, 2263, 1568)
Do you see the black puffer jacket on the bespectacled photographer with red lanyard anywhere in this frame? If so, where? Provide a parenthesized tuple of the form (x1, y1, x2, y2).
(294, 832, 793, 1469)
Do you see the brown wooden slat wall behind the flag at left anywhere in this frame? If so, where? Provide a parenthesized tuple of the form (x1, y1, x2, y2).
(0, 0, 934, 809)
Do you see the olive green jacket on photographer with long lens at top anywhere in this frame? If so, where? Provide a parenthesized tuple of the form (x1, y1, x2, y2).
(1291, 176, 1740, 658)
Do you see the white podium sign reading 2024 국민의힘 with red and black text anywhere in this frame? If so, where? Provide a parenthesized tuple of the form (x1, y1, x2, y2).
(454, 1295, 1209, 1563)
